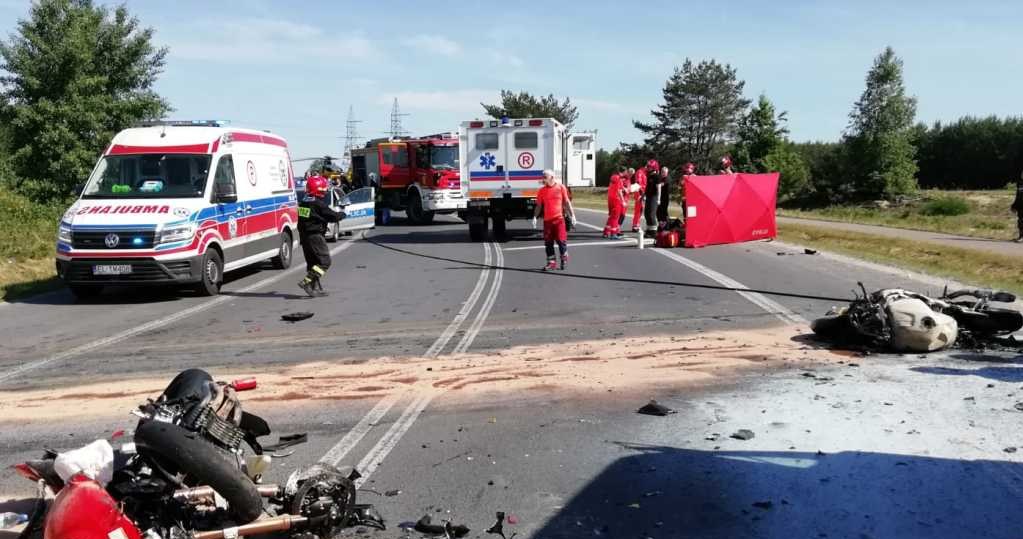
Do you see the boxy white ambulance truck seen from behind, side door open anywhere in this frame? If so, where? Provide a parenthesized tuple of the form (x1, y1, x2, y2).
(458, 118, 596, 241)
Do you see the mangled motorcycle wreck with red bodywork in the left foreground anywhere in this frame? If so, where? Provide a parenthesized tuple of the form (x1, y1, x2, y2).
(14, 369, 384, 539)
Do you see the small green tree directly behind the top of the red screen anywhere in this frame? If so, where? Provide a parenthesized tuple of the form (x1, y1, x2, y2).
(731, 94, 789, 172)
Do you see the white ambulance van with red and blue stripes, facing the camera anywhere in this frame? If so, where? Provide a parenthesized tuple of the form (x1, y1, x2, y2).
(56, 122, 299, 298)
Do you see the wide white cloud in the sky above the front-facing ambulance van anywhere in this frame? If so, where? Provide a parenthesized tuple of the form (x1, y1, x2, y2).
(168, 18, 377, 64)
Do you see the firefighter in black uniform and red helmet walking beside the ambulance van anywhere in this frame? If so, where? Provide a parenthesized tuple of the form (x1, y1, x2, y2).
(299, 176, 345, 297)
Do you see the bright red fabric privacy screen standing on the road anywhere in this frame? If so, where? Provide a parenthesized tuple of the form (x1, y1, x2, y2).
(685, 172, 779, 248)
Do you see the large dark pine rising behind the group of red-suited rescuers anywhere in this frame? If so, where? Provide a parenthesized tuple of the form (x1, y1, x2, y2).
(633, 58, 750, 170)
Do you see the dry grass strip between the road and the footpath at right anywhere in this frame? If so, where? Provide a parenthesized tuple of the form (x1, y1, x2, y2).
(779, 224, 1023, 295)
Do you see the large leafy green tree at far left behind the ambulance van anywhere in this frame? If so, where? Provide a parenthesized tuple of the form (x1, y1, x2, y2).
(0, 0, 169, 199)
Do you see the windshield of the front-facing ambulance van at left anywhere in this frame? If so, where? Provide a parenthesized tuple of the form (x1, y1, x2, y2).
(82, 153, 210, 198)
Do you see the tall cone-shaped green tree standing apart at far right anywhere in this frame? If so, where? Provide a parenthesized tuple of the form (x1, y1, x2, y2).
(844, 47, 917, 198)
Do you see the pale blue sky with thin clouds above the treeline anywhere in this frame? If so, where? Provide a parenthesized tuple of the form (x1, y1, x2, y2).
(0, 0, 1023, 156)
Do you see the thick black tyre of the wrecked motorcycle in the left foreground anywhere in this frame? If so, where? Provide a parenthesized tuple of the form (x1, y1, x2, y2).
(135, 420, 263, 525)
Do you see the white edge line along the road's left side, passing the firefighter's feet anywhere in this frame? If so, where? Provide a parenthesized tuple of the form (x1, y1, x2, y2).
(0, 236, 361, 385)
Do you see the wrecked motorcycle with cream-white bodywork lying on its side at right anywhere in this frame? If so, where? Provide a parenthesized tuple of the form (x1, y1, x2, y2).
(810, 283, 1023, 353)
